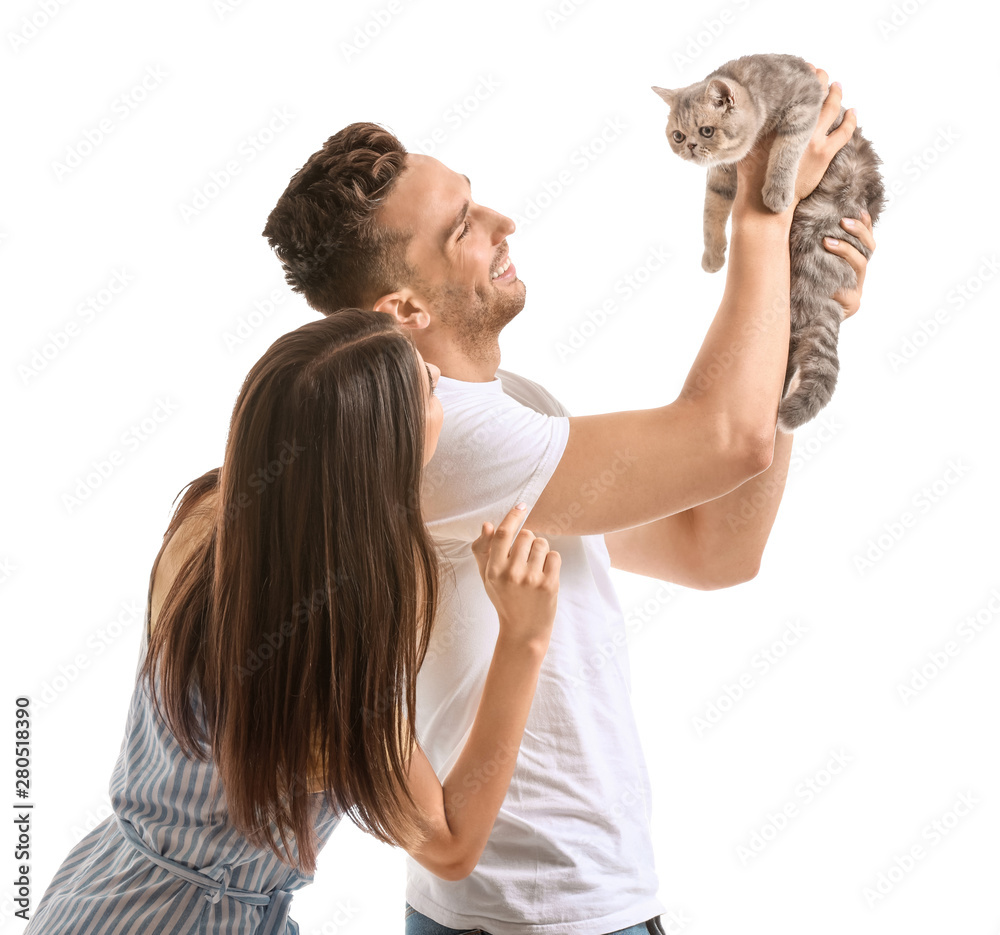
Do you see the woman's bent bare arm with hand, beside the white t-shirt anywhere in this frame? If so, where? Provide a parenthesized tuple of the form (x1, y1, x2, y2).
(398, 508, 560, 880)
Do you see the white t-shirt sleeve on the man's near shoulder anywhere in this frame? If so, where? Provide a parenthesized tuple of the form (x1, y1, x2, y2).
(421, 392, 569, 542)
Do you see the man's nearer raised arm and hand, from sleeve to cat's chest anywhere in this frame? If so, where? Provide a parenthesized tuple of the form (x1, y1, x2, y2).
(524, 74, 856, 535)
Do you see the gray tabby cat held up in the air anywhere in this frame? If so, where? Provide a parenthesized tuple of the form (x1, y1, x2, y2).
(653, 55, 885, 432)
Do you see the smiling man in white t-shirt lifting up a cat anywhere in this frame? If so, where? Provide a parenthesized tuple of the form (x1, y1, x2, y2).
(264, 71, 874, 935)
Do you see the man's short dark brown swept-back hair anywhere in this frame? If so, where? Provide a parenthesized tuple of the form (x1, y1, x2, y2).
(263, 123, 414, 315)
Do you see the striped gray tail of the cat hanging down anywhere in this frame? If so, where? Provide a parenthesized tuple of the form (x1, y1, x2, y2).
(778, 296, 842, 432)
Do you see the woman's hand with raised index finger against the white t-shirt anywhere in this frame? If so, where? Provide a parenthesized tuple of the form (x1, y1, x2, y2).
(472, 507, 562, 648)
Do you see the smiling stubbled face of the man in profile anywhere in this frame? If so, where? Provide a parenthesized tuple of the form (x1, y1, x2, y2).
(381, 153, 525, 356)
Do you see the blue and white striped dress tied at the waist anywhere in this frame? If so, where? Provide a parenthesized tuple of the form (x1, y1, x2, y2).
(25, 628, 340, 935)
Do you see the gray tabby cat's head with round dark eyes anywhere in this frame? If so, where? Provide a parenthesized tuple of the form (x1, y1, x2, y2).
(653, 78, 760, 166)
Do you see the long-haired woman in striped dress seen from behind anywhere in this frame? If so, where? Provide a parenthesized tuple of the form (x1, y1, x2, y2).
(26, 309, 560, 935)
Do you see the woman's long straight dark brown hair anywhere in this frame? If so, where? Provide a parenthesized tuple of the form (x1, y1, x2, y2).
(143, 309, 437, 871)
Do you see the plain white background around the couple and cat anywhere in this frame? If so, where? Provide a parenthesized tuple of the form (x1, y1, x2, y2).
(0, 0, 1000, 935)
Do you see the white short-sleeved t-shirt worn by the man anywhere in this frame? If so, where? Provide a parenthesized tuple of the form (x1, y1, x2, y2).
(406, 370, 664, 935)
